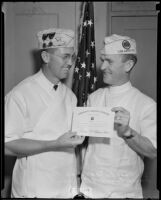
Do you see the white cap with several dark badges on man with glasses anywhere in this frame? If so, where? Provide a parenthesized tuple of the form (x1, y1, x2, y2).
(37, 28, 74, 49)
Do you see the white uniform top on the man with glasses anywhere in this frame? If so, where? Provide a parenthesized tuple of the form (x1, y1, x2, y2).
(5, 70, 77, 198)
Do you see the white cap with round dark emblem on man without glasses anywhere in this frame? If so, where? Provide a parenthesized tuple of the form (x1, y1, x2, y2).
(101, 34, 137, 54)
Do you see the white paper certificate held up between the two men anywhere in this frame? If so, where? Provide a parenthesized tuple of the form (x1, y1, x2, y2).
(72, 107, 115, 137)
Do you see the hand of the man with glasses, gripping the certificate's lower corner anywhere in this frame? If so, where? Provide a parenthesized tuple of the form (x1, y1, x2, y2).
(56, 131, 85, 147)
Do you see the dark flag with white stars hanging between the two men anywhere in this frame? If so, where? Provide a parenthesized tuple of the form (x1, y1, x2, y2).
(72, 2, 97, 106)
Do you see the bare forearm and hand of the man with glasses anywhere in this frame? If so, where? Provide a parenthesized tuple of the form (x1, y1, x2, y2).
(5, 131, 85, 157)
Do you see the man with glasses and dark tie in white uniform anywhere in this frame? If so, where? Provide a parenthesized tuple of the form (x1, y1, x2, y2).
(5, 28, 84, 198)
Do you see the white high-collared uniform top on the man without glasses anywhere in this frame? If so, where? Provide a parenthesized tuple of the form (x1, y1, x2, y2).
(80, 82, 156, 198)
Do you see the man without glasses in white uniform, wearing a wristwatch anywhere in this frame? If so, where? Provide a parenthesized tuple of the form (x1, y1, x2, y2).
(80, 34, 156, 198)
